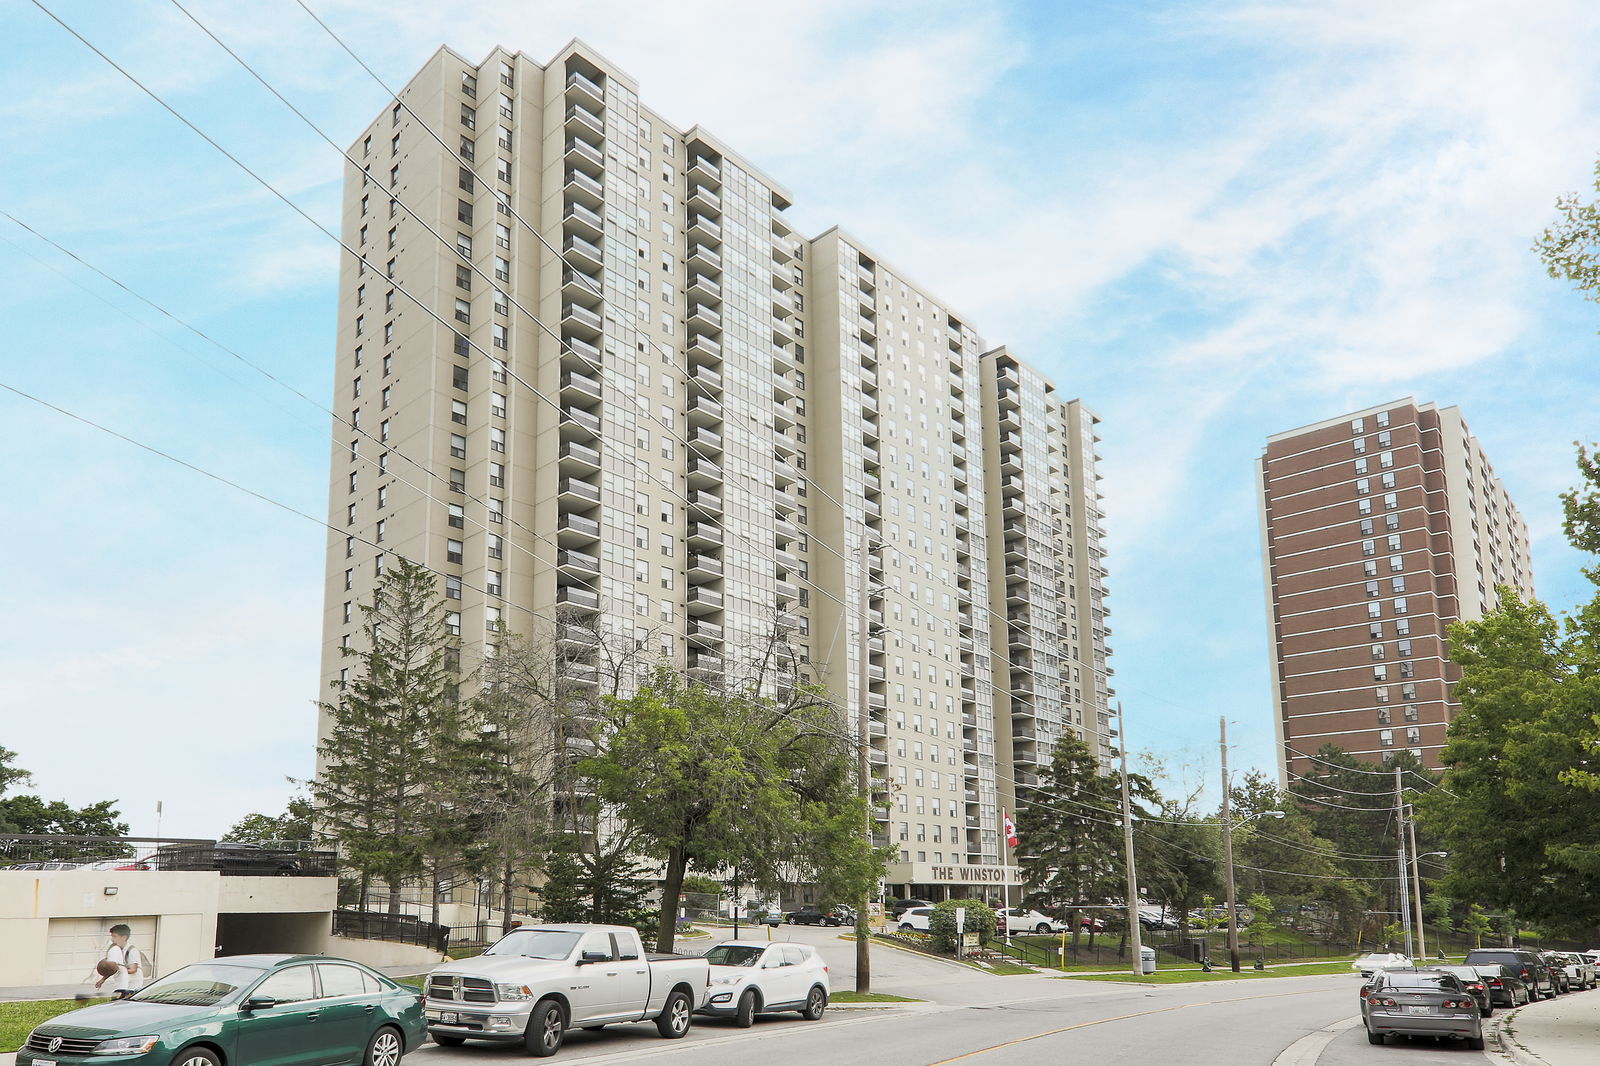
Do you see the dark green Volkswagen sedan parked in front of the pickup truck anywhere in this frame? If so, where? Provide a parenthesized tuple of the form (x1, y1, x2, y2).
(16, 956, 427, 1066)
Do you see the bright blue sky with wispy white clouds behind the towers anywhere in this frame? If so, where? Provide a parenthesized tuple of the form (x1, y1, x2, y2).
(0, 0, 1600, 836)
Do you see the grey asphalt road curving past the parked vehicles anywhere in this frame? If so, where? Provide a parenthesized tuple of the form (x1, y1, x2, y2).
(405, 927, 1486, 1066)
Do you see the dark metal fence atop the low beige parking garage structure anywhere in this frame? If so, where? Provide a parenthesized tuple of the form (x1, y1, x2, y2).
(0, 832, 338, 877)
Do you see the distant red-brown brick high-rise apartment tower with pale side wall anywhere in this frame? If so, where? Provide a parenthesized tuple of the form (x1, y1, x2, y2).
(1258, 399, 1533, 781)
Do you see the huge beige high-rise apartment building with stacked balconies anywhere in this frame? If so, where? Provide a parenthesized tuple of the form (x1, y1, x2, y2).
(323, 42, 1112, 896)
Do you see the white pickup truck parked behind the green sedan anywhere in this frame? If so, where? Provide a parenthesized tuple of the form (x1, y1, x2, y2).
(426, 925, 710, 1055)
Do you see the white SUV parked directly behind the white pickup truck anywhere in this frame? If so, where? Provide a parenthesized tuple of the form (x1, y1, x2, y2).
(699, 940, 829, 1029)
